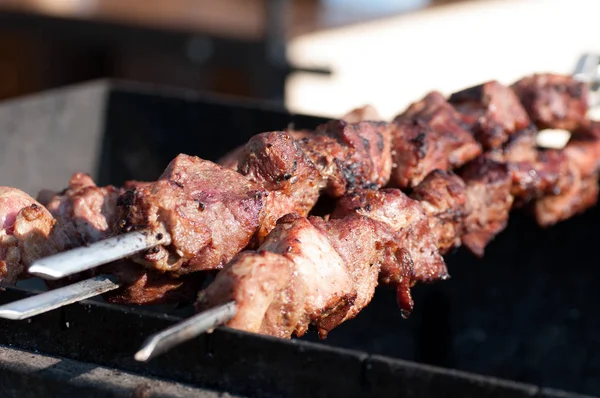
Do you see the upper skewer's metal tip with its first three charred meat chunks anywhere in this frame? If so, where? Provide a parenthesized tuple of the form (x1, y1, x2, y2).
(31, 116, 391, 278)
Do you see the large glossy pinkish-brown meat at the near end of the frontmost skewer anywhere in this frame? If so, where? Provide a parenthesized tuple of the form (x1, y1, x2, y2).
(197, 214, 412, 338)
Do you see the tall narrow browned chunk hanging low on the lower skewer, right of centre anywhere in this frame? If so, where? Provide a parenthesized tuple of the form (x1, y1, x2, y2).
(460, 157, 513, 257)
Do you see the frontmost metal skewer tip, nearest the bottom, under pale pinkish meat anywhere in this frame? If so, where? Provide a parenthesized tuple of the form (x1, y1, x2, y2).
(135, 301, 237, 362)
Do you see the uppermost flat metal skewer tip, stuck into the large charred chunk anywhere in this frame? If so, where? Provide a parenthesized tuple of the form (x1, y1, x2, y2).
(28, 231, 171, 279)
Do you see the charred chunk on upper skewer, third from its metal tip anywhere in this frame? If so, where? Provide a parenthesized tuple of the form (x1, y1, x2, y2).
(299, 120, 392, 197)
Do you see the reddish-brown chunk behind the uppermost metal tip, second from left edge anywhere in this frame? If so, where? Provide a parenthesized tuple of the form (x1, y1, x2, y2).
(38, 173, 122, 247)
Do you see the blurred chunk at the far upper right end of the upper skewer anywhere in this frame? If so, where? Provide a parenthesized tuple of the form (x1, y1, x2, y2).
(512, 73, 589, 130)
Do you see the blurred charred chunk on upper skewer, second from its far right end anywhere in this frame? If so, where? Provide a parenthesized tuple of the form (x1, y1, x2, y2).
(449, 81, 531, 149)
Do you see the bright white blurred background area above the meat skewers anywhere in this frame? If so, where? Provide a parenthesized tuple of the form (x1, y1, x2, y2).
(286, 0, 600, 119)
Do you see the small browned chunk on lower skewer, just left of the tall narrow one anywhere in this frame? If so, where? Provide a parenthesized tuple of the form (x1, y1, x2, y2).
(410, 170, 470, 254)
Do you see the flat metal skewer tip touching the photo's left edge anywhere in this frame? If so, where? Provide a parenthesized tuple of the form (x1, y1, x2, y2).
(0, 275, 119, 320)
